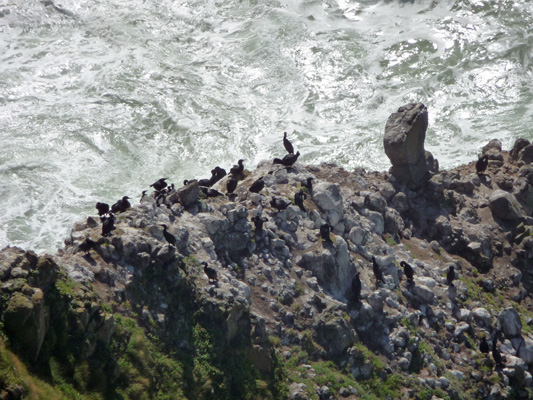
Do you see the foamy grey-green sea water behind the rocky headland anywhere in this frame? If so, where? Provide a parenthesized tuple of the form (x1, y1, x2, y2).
(0, 0, 533, 252)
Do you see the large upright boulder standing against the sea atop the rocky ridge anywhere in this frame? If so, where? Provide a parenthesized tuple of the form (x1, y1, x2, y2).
(383, 103, 430, 189)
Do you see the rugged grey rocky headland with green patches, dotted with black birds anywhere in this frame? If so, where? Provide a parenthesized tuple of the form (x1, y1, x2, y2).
(0, 104, 533, 399)
